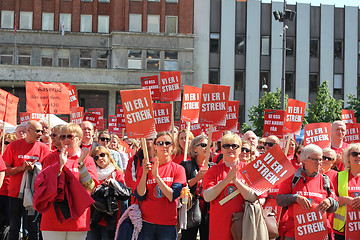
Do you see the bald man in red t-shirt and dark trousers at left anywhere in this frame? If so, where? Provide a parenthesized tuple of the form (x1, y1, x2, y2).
(3, 121, 50, 240)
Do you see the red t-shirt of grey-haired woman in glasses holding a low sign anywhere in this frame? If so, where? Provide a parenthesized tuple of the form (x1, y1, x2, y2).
(278, 173, 337, 237)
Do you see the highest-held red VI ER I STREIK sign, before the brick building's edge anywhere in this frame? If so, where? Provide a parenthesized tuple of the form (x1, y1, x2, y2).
(160, 72, 181, 102)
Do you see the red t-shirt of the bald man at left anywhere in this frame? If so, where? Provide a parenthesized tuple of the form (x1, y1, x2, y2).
(3, 139, 50, 198)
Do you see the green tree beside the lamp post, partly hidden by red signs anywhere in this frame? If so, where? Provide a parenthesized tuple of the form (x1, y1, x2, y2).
(241, 88, 288, 136)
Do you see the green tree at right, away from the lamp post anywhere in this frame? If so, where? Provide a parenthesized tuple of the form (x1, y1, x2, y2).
(305, 81, 344, 123)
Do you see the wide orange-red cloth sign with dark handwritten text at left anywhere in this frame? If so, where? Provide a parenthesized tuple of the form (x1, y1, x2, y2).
(25, 82, 70, 114)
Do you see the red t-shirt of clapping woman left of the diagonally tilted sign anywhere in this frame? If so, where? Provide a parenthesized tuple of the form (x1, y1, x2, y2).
(204, 162, 245, 240)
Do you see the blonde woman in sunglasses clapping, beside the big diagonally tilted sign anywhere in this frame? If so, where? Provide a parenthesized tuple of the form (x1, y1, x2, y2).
(203, 133, 257, 240)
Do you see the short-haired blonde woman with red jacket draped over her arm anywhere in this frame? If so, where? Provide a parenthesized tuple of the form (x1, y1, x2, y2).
(40, 123, 98, 240)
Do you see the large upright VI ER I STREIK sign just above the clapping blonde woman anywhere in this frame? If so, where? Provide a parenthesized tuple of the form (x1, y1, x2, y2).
(199, 84, 230, 126)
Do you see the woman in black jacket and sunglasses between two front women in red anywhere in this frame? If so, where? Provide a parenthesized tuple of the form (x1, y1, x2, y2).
(181, 135, 215, 240)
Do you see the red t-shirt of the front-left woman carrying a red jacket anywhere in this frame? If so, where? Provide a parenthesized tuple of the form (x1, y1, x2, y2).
(40, 152, 99, 232)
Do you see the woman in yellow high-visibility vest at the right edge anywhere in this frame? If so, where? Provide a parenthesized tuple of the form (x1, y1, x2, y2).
(333, 143, 360, 240)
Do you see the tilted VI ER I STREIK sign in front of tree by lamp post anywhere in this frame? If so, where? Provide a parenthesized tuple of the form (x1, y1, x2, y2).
(284, 98, 306, 133)
